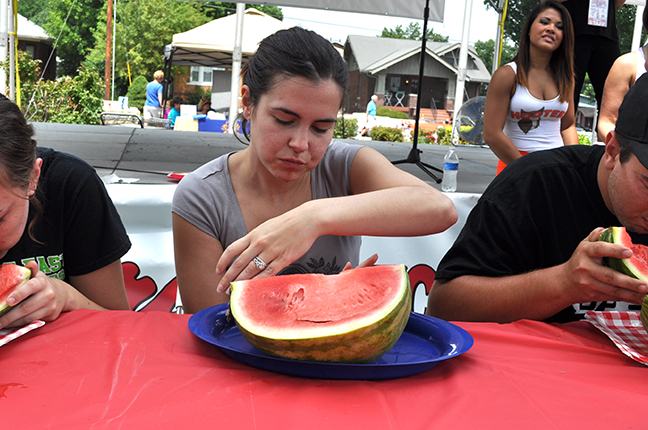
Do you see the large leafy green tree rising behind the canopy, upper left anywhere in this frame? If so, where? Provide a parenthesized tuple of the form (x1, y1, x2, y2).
(18, 0, 283, 80)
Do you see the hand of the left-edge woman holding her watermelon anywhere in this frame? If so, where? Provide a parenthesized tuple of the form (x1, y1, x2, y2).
(0, 261, 76, 327)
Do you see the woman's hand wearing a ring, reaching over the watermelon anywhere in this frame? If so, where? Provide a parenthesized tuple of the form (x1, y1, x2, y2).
(216, 202, 320, 293)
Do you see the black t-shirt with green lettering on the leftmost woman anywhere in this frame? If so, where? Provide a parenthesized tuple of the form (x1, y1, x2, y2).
(0, 148, 131, 283)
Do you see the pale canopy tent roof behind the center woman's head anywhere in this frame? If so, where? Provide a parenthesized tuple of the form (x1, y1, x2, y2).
(165, 8, 290, 67)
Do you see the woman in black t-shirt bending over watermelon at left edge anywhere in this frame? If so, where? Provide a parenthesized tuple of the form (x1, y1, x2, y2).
(0, 95, 131, 327)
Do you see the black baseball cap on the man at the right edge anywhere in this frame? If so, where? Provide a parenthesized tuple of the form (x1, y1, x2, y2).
(615, 73, 648, 169)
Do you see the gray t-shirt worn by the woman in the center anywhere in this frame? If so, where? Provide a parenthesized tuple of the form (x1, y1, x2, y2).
(171, 141, 362, 275)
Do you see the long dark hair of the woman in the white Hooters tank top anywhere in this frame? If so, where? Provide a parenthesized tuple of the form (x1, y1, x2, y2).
(514, 0, 574, 102)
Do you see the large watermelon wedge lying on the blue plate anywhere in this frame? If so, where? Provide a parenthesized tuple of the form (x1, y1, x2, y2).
(230, 265, 411, 362)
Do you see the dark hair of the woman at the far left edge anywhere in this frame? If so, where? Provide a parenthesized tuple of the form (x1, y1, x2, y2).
(0, 94, 42, 240)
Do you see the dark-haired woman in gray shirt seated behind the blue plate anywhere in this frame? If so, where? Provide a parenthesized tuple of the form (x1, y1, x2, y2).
(172, 27, 457, 313)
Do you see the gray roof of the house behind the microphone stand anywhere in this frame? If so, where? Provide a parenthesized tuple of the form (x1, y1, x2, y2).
(345, 35, 491, 82)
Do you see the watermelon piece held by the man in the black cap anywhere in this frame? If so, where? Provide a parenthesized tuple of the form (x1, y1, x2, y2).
(599, 227, 648, 331)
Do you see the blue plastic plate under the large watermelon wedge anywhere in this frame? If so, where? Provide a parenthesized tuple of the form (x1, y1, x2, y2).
(189, 304, 473, 379)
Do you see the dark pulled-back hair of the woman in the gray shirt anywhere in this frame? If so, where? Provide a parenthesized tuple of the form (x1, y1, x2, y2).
(235, 27, 349, 143)
